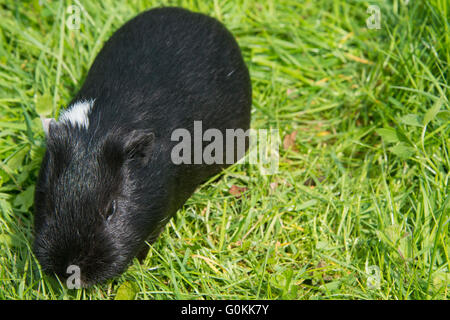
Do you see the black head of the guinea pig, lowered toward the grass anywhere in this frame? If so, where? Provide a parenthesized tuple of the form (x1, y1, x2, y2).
(33, 120, 164, 287)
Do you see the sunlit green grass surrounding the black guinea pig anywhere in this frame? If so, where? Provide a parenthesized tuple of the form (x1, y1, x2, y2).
(0, 0, 450, 299)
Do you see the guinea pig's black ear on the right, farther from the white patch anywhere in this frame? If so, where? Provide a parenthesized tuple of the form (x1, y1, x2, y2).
(125, 129, 155, 165)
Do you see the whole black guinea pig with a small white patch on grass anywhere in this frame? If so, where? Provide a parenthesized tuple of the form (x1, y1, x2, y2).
(33, 8, 252, 287)
